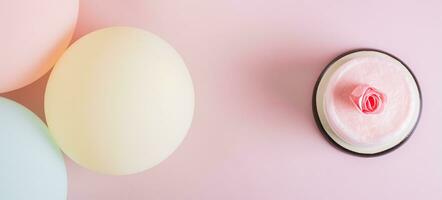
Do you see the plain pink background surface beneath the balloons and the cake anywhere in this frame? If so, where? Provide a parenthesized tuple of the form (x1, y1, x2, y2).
(2, 0, 442, 200)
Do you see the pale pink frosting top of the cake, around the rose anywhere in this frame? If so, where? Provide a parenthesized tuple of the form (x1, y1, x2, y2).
(323, 56, 419, 146)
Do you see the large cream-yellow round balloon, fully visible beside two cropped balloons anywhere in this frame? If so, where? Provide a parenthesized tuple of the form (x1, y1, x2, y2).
(45, 27, 194, 175)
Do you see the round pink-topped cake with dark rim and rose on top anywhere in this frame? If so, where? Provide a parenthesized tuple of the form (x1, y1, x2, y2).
(313, 49, 422, 156)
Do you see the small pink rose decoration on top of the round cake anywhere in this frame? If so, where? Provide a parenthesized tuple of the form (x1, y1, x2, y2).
(350, 84, 386, 114)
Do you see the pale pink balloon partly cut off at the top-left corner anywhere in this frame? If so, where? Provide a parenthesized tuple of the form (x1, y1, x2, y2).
(0, 0, 78, 93)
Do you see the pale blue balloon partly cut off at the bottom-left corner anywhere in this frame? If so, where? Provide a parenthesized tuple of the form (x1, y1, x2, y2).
(0, 97, 67, 200)
